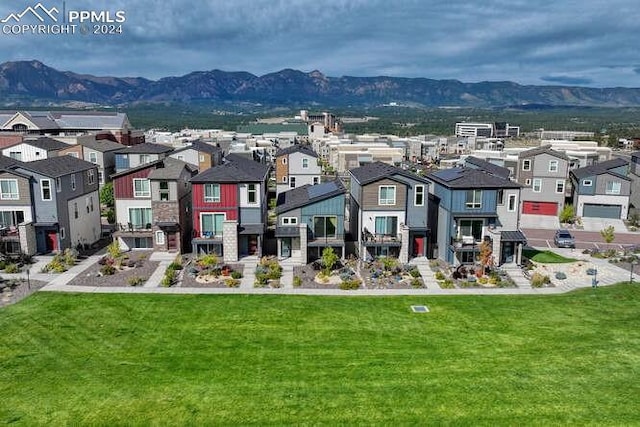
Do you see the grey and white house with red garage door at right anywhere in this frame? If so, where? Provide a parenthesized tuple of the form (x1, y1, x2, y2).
(515, 145, 569, 216)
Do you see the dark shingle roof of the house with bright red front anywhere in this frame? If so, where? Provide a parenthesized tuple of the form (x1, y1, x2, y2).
(191, 154, 270, 182)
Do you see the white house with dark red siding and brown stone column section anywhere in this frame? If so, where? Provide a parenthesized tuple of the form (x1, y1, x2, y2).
(112, 158, 195, 252)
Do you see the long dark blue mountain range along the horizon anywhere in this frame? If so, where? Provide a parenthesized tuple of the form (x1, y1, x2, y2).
(0, 60, 640, 107)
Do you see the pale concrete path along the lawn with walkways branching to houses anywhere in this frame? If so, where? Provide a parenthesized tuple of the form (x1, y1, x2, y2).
(36, 249, 640, 296)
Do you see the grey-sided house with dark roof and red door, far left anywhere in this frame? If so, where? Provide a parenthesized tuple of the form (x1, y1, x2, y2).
(11, 156, 102, 253)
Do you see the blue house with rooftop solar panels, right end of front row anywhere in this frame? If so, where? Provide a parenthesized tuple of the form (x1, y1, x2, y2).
(427, 167, 526, 265)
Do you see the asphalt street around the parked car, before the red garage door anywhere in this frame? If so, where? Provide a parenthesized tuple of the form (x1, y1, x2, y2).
(522, 228, 640, 249)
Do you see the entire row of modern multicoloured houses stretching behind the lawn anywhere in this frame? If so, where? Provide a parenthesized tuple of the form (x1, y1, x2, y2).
(0, 141, 640, 270)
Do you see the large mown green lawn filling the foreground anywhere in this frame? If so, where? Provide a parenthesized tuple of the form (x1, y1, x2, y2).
(0, 290, 640, 426)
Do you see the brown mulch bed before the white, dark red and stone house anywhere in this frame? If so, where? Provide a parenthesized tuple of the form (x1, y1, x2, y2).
(68, 251, 160, 287)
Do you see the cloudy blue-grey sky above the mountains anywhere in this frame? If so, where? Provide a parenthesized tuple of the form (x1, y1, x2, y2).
(0, 0, 640, 87)
